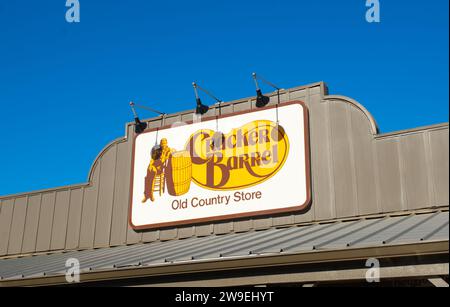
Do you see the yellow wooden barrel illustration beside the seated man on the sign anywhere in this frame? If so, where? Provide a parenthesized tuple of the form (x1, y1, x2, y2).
(165, 150, 192, 196)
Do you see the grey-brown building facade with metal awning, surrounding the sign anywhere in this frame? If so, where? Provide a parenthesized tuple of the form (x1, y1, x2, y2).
(0, 82, 449, 286)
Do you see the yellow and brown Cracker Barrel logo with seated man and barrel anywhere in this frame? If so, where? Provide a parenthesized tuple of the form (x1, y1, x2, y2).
(142, 120, 289, 203)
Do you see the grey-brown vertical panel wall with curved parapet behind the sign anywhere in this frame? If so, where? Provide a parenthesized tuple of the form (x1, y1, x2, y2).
(0, 83, 449, 256)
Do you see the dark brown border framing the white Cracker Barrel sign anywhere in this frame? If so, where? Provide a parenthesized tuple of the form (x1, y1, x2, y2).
(128, 100, 311, 230)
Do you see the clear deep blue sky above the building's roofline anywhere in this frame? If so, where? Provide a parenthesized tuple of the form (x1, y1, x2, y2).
(0, 0, 449, 195)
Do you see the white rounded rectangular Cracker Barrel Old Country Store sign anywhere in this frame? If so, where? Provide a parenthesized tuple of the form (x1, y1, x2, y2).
(129, 101, 311, 229)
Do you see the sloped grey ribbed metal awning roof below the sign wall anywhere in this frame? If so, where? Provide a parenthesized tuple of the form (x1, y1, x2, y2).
(0, 211, 449, 280)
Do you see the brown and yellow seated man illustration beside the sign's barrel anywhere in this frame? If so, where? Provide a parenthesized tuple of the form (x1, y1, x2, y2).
(142, 138, 174, 203)
